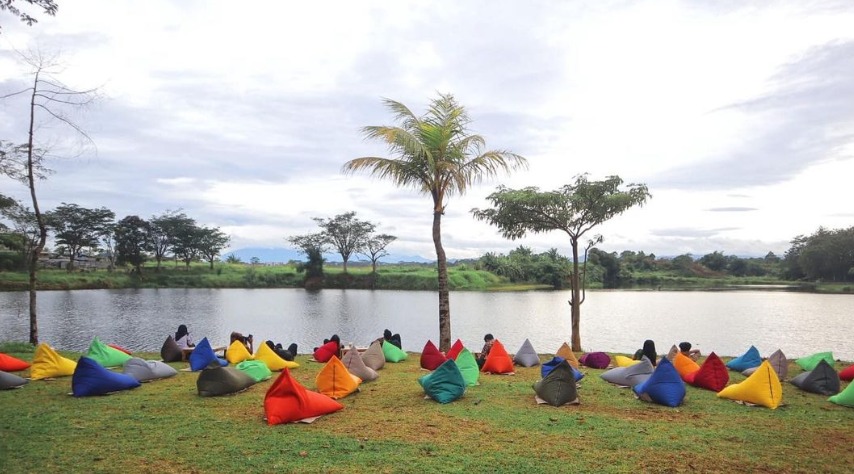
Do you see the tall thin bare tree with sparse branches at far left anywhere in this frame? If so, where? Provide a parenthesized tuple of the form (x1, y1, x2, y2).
(0, 51, 96, 344)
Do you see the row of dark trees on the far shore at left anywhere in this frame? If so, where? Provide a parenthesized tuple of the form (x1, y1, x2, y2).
(0, 195, 230, 273)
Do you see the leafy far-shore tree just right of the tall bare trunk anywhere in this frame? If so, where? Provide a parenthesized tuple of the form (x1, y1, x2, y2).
(47, 203, 116, 272)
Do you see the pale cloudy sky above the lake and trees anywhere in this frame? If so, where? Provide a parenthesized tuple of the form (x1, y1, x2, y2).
(0, 0, 854, 259)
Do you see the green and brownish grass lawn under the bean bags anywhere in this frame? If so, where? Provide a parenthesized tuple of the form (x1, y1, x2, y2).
(0, 349, 854, 473)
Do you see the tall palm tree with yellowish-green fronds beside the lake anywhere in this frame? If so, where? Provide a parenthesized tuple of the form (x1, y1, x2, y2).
(343, 94, 527, 351)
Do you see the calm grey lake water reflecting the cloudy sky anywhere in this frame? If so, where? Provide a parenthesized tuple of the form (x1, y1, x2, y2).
(0, 289, 854, 360)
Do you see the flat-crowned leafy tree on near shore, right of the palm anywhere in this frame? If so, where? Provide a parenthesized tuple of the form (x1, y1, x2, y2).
(472, 174, 650, 351)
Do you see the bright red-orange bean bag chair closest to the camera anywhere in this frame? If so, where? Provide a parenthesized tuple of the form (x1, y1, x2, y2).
(264, 369, 344, 426)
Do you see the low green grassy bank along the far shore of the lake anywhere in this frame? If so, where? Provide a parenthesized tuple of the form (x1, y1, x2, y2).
(0, 263, 854, 294)
